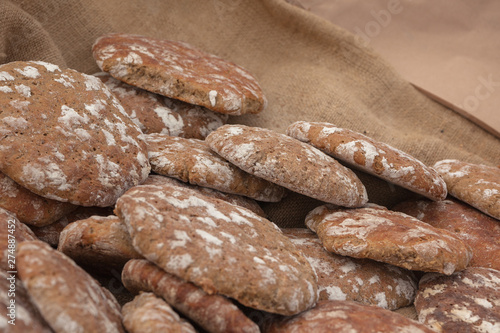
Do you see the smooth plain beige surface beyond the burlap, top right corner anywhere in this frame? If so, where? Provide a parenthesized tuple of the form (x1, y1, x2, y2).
(293, 0, 500, 137)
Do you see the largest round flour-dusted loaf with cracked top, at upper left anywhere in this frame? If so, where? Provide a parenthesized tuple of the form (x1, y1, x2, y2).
(0, 61, 150, 206)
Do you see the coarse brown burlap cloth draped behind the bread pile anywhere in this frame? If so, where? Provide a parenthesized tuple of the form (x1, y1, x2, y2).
(0, 0, 500, 226)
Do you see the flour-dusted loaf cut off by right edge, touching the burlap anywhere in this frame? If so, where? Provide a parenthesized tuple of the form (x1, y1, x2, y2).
(434, 160, 500, 220)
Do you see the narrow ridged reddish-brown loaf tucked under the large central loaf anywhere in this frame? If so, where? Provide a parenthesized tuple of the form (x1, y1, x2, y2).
(122, 259, 259, 333)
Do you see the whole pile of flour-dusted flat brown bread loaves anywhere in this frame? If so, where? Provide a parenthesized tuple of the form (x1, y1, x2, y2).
(0, 33, 500, 333)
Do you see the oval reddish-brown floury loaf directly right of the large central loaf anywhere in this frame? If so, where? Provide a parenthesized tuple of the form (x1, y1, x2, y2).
(306, 204, 472, 275)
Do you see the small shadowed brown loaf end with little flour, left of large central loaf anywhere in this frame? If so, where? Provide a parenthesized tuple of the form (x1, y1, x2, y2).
(57, 215, 142, 270)
